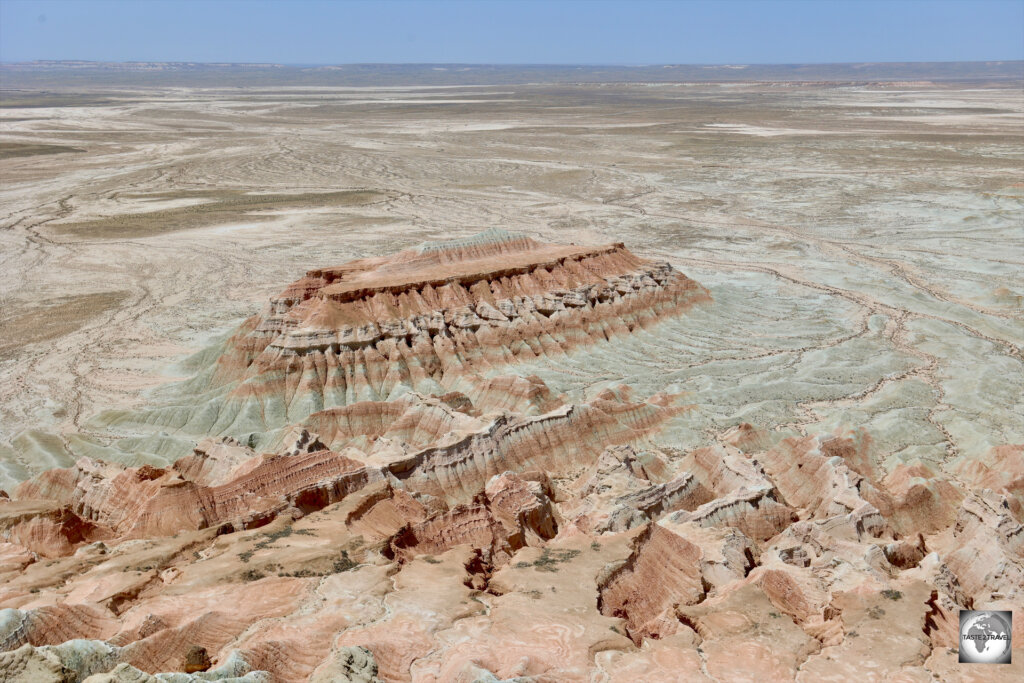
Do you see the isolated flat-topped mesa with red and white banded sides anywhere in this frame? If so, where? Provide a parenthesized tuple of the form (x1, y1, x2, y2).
(203, 236, 708, 421)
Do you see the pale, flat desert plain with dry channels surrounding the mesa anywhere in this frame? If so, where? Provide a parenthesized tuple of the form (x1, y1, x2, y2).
(0, 84, 1024, 487)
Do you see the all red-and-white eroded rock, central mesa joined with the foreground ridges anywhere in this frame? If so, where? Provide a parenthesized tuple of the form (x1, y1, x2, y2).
(0, 232, 1024, 683)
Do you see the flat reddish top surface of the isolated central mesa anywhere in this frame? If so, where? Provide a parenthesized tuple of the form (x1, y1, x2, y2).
(306, 230, 639, 300)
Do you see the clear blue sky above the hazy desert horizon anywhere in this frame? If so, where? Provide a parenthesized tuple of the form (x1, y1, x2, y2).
(0, 0, 1024, 65)
